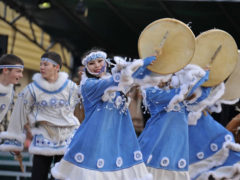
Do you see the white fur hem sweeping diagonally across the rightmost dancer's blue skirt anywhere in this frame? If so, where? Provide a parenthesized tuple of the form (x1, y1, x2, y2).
(189, 141, 240, 178)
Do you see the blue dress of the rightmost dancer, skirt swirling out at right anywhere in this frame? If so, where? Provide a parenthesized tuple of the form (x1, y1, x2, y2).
(189, 87, 240, 179)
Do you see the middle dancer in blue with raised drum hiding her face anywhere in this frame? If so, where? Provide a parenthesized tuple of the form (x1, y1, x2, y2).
(138, 18, 198, 180)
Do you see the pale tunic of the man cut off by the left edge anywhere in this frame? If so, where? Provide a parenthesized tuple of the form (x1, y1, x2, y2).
(0, 83, 14, 122)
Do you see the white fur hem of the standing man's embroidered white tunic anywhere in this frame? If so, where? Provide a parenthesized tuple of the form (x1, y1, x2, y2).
(28, 143, 67, 156)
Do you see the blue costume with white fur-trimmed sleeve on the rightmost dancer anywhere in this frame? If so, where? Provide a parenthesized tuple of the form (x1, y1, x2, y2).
(187, 83, 240, 180)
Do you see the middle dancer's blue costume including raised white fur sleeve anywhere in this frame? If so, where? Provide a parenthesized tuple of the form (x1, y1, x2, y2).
(139, 65, 205, 180)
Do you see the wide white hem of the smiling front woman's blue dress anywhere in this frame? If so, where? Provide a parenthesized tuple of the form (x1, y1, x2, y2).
(51, 159, 152, 180)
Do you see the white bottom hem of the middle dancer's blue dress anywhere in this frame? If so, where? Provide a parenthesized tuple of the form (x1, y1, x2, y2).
(147, 167, 190, 180)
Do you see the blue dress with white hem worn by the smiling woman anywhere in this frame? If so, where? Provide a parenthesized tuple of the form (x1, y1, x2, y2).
(52, 77, 150, 180)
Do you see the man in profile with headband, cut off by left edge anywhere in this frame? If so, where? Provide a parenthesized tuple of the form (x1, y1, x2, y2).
(0, 54, 24, 122)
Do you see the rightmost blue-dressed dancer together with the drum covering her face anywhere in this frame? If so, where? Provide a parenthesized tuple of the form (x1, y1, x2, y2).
(184, 29, 240, 180)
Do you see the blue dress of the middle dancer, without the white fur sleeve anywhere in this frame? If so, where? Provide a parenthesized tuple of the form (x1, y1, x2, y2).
(139, 87, 189, 179)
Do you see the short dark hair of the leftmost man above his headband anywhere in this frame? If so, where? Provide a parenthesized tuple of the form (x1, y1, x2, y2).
(0, 54, 24, 74)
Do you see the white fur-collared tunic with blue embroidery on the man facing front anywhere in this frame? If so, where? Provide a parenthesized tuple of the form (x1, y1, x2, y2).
(0, 72, 79, 156)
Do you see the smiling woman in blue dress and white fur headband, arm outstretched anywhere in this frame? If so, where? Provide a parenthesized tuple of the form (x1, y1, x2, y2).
(52, 50, 155, 180)
